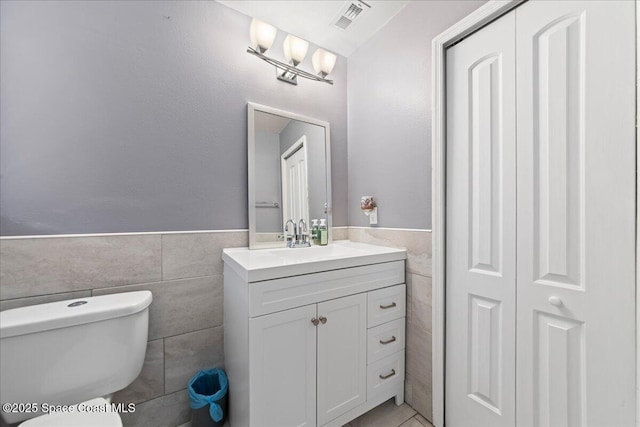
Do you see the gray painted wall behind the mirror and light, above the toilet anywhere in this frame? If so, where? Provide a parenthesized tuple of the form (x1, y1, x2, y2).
(0, 1, 347, 235)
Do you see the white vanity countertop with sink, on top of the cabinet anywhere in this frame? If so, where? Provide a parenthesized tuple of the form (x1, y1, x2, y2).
(222, 240, 407, 282)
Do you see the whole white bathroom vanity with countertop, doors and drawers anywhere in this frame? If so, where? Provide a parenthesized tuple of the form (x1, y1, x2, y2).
(222, 241, 406, 427)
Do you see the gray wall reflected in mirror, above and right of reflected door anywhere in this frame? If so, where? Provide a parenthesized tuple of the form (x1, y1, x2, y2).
(280, 120, 328, 226)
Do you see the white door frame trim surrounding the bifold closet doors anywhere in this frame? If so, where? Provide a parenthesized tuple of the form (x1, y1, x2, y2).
(431, 0, 640, 427)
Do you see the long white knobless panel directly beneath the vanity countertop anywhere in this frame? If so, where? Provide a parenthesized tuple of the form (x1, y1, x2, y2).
(249, 260, 404, 322)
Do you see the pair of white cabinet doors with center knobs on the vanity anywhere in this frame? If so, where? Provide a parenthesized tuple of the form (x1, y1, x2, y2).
(249, 294, 367, 426)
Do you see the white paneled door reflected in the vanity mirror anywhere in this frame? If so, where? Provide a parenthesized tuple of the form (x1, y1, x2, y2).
(281, 135, 309, 231)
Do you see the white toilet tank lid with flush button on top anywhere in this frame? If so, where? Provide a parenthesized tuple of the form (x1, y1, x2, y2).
(0, 291, 153, 338)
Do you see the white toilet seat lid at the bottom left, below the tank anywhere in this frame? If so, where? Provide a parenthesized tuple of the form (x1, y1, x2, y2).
(19, 397, 122, 427)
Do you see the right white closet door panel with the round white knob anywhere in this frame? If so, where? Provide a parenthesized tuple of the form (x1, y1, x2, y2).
(516, 1, 636, 427)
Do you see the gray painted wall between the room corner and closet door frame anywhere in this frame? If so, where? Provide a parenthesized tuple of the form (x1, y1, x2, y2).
(348, 0, 484, 229)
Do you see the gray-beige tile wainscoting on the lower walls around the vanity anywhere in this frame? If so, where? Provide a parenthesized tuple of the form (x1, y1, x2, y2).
(0, 227, 432, 427)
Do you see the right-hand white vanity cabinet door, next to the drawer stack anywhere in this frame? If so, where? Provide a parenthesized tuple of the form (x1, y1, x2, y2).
(318, 293, 367, 426)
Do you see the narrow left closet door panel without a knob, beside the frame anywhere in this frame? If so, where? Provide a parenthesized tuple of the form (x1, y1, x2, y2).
(445, 12, 516, 427)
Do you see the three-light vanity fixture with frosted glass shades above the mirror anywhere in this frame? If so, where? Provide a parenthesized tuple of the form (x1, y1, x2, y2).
(247, 18, 337, 85)
